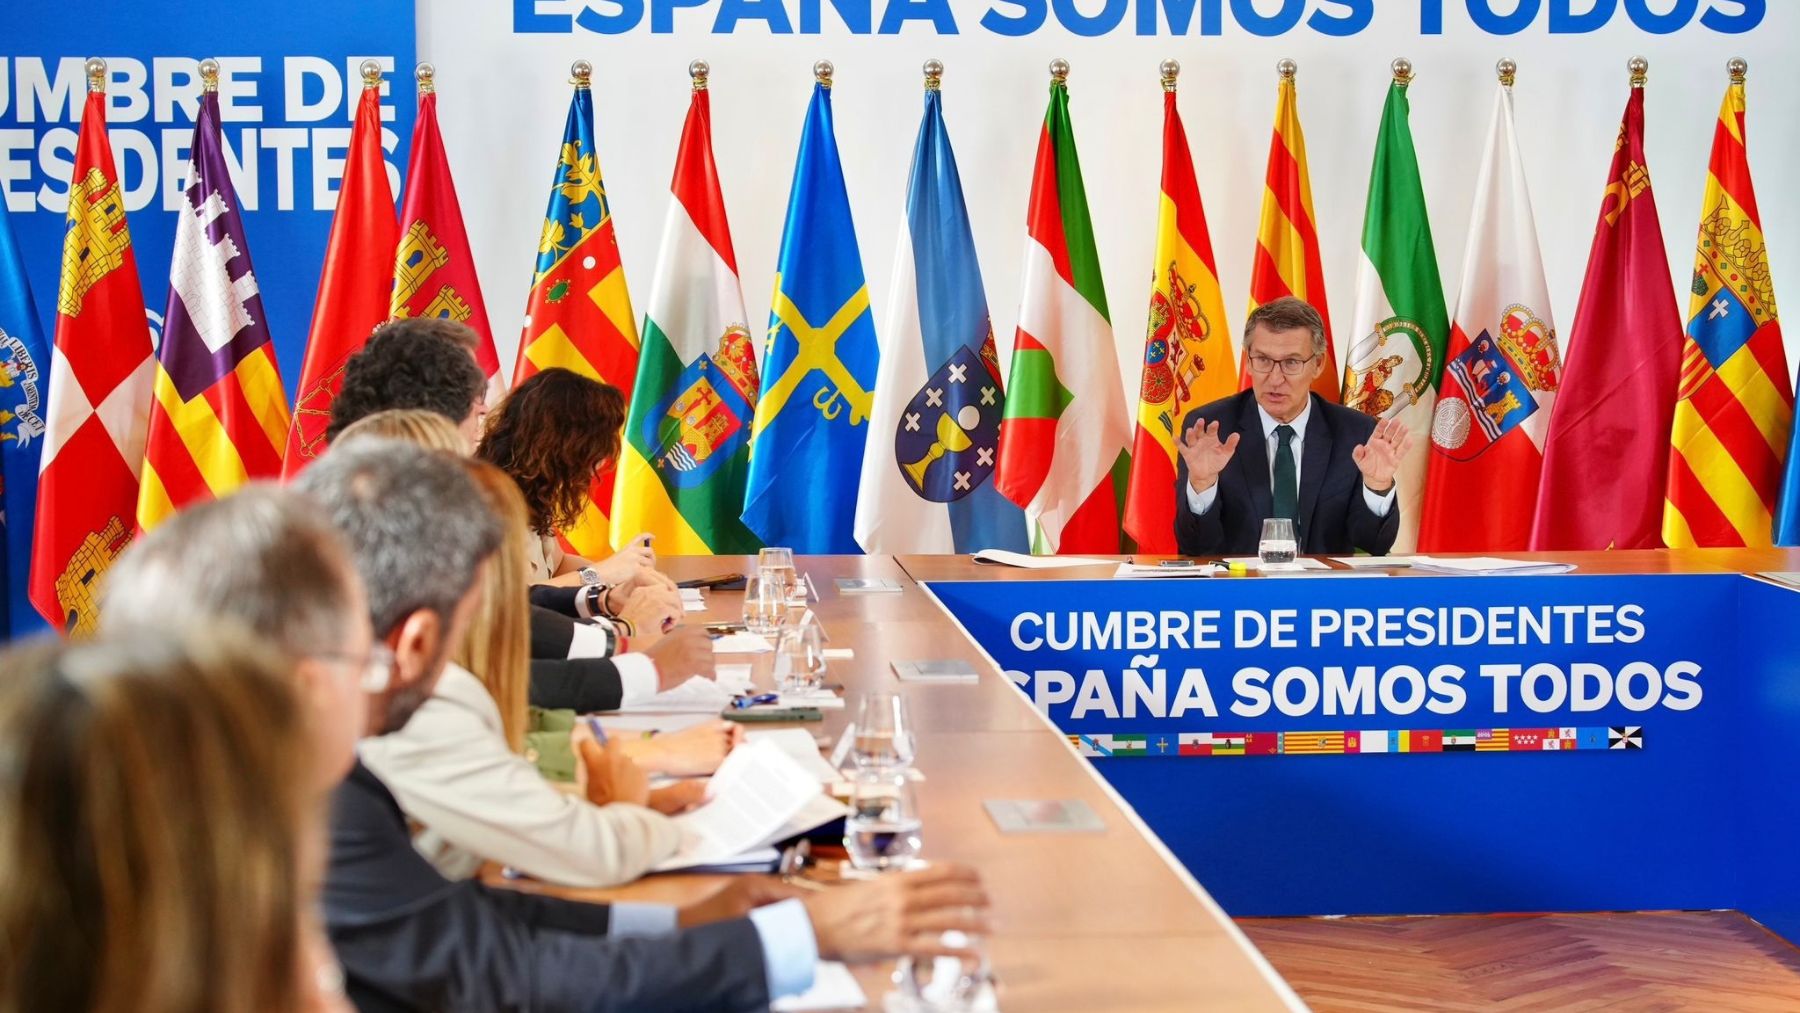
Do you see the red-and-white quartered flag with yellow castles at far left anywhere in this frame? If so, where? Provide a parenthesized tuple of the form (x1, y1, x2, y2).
(31, 59, 155, 633)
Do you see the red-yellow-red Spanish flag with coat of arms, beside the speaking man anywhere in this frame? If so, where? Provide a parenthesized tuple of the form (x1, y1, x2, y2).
(1125, 74, 1238, 556)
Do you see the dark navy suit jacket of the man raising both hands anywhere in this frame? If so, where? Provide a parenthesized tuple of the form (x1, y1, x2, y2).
(1175, 390, 1400, 556)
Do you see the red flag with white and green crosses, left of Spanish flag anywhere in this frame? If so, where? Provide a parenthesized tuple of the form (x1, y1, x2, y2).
(995, 74, 1130, 552)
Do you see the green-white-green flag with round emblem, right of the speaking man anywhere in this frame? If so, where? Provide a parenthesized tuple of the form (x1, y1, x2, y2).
(1343, 68, 1451, 552)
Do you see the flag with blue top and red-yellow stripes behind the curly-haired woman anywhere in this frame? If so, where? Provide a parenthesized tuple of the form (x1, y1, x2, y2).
(513, 59, 637, 560)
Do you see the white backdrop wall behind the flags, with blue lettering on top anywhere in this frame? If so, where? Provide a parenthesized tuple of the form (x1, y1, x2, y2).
(421, 0, 1800, 415)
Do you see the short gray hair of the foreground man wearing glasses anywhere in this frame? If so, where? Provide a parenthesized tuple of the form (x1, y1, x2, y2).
(101, 482, 364, 659)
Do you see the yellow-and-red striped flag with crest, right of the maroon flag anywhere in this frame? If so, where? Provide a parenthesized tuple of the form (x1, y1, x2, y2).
(1663, 61, 1795, 549)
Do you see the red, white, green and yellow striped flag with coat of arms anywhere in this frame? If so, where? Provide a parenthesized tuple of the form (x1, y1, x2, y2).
(612, 63, 760, 556)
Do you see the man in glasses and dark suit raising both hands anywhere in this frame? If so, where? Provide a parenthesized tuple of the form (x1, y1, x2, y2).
(1175, 297, 1413, 556)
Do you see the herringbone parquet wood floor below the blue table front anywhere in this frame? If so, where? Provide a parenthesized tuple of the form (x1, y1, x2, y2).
(1238, 912, 1800, 1013)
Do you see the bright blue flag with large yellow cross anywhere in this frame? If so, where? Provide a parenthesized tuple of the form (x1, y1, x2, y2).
(743, 74, 880, 552)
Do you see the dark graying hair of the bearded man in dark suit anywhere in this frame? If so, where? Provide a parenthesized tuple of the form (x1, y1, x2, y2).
(295, 437, 502, 637)
